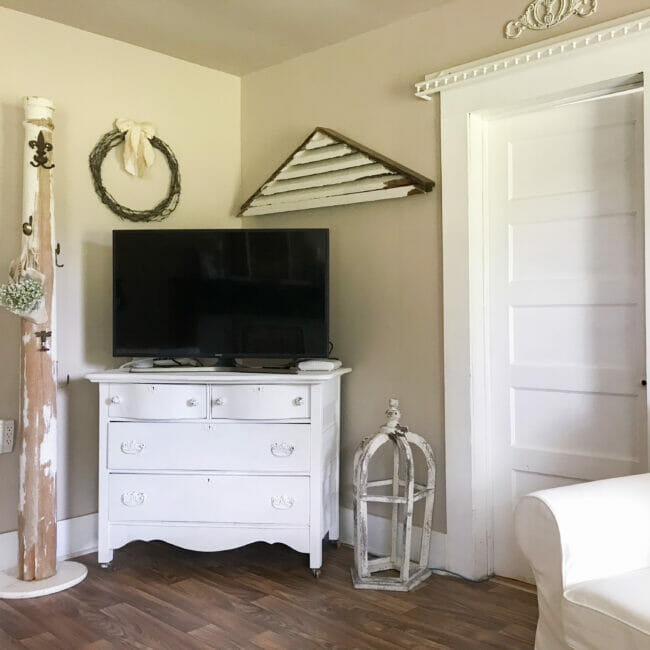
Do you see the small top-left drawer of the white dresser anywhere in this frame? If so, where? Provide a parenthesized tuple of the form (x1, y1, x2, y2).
(108, 384, 207, 420)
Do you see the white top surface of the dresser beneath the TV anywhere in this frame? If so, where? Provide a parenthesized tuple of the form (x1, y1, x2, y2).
(86, 368, 352, 384)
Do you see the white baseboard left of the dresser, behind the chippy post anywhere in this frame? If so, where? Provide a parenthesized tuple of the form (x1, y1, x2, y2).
(0, 513, 97, 571)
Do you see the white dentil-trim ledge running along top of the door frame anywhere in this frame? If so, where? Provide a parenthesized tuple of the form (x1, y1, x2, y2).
(415, 10, 650, 100)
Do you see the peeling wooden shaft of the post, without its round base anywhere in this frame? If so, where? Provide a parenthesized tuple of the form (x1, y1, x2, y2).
(18, 97, 56, 580)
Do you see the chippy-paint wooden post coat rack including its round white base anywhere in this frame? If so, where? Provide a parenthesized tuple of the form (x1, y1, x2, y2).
(0, 97, 87, 598)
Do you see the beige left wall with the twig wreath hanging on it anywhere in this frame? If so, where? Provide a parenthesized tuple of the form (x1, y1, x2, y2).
(0, 9, 240, 532)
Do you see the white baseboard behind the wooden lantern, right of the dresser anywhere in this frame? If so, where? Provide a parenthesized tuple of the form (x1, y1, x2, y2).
(340, 508, 447, 569)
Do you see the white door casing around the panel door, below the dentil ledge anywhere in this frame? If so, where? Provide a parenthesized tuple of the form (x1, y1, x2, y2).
(432, 24, 650, 578)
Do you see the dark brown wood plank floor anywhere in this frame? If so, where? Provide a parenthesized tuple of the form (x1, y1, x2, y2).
(0, 542, 537, 650)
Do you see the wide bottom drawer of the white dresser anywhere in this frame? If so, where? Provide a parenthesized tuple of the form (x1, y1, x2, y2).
(108, 474, 309, 526)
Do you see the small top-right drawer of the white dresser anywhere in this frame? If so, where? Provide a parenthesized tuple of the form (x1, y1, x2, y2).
(210, 384, 309, 420)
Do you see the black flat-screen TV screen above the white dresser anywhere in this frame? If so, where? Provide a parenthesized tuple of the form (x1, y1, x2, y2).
(113, 229, 329, 358)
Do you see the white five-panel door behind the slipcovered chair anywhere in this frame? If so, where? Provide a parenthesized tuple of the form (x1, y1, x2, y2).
(485, 92, 647, 582)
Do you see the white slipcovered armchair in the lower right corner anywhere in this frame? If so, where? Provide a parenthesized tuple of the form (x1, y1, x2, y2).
(515, 474, 650, 650)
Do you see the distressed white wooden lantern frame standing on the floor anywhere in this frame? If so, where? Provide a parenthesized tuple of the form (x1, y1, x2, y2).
(352, 399, 436, 591)
